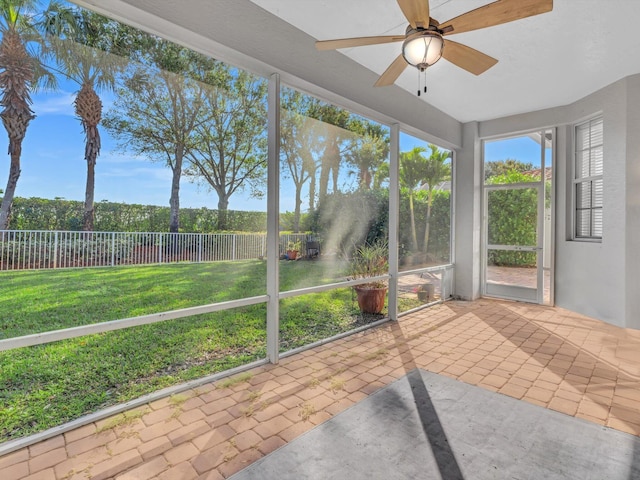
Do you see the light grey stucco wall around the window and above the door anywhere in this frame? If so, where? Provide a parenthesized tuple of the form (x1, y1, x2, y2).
(458, 75, 640, 328)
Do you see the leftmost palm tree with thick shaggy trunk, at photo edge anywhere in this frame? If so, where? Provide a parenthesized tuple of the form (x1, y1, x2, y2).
(0, 0, 39, 230)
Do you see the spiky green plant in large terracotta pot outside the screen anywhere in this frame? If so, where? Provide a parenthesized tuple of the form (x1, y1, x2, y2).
(349, 241, 389, 314)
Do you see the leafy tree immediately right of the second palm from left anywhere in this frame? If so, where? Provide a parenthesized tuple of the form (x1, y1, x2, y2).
(104, 31, 216, 232)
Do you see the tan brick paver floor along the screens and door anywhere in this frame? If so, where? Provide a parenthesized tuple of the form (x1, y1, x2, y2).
(0, 300, 640, 480)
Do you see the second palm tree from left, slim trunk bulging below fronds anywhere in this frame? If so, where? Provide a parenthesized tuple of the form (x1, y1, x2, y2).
(42, 2, 127, 231)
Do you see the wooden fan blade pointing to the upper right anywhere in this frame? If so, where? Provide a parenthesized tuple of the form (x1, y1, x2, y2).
(438, 0, 553, 35)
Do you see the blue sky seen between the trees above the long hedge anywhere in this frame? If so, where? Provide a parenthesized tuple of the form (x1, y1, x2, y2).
(0, 82, 450, 211)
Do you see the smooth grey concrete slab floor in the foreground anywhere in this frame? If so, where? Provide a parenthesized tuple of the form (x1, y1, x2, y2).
(231, 369, 640, 480)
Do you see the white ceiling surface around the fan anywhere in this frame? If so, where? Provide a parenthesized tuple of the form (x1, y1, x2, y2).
(251, 0, 640, 122)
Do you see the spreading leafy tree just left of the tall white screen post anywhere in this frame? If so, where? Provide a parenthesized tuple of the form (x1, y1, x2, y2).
(185, 62, 267, 230)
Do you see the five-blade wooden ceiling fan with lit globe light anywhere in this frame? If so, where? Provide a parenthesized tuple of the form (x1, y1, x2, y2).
(316, 0, 553, 87)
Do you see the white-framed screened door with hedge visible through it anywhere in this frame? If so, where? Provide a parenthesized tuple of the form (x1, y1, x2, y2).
(482, 130, 552, 304)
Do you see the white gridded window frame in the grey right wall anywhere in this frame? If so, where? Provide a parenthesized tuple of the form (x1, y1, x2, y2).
(570, 115, 604, 243)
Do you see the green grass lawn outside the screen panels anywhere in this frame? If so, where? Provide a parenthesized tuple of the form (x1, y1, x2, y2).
(0, 260, 422, 442)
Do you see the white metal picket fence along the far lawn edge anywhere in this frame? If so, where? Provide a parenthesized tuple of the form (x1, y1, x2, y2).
(0, 230, 312, 270)
